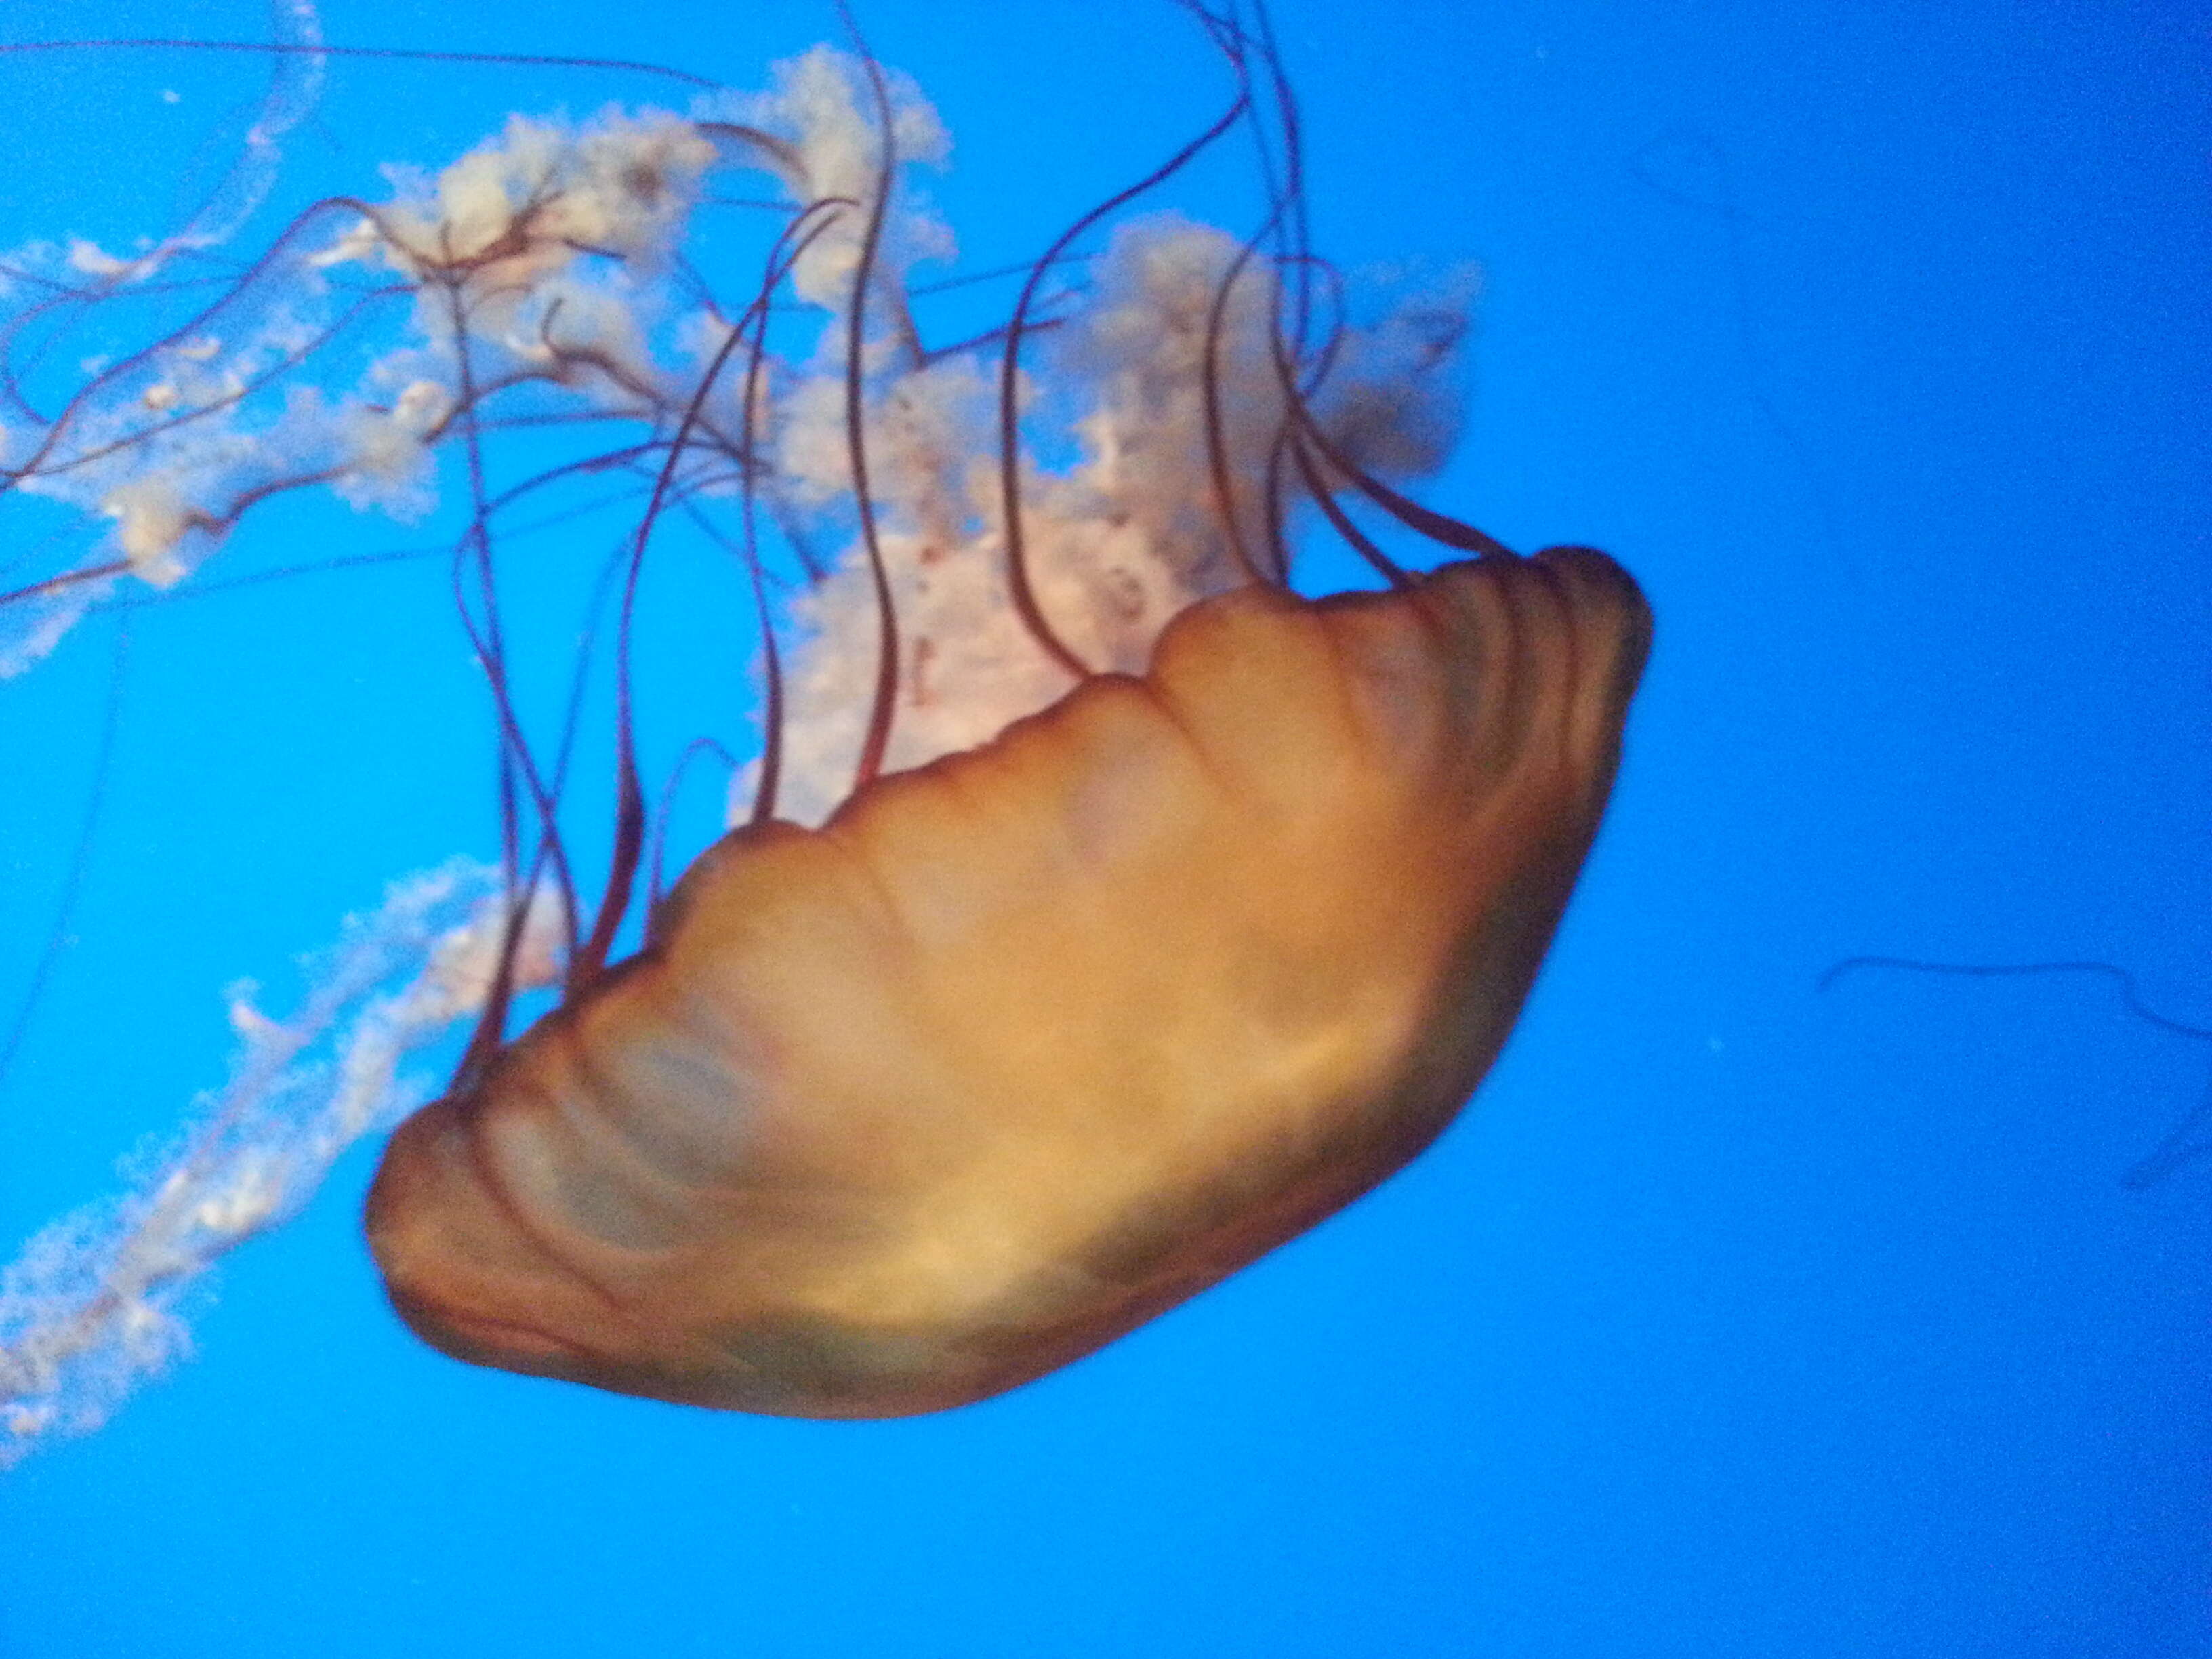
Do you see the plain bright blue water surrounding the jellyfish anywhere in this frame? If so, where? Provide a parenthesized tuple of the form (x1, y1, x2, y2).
(0, 0, 2212, 1659)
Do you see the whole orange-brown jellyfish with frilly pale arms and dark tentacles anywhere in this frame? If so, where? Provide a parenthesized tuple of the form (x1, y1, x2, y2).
(0, 5, 1650, 1429)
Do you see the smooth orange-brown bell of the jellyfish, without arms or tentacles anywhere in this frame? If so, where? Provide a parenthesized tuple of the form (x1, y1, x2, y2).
(367, 548, 1648, 1418)
